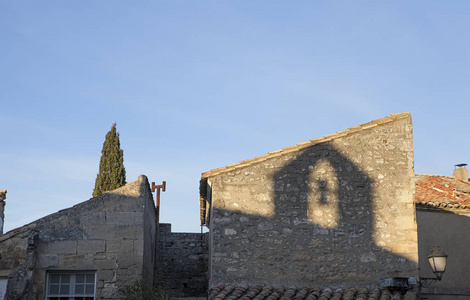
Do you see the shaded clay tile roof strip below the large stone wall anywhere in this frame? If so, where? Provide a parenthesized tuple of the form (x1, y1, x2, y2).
(208, 285, 405, 300)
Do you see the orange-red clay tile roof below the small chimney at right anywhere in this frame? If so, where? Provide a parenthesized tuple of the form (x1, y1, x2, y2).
(415, 175, 470, 209)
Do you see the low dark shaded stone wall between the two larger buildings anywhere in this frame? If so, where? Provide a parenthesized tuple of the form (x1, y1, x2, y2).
(155, 224, 209, 297)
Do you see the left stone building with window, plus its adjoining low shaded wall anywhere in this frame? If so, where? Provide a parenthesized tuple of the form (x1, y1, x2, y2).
(0, 175, 208, 300)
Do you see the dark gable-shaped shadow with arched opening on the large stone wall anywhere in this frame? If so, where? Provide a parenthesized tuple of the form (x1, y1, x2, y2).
(211, 144, 416, 286)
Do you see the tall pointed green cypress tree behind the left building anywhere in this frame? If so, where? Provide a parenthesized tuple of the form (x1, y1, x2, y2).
(93, 123, 126, 197)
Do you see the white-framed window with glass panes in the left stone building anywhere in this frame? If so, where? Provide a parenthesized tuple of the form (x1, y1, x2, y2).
(47, 272, 95, 300)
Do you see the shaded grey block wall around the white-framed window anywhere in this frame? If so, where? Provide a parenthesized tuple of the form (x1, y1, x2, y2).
(0, 176, 155, 299)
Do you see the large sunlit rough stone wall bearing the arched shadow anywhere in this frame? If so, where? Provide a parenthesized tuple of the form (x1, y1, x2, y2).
(207, 113, 418, 287)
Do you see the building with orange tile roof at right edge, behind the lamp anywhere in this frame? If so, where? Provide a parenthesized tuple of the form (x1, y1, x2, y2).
(415, 168, 470, 300)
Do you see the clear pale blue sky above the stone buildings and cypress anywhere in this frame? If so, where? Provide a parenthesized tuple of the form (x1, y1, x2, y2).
(0, 0, 470, 231)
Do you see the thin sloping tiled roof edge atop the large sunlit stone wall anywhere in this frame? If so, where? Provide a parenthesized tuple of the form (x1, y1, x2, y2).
(202, 112, 411, 178)
